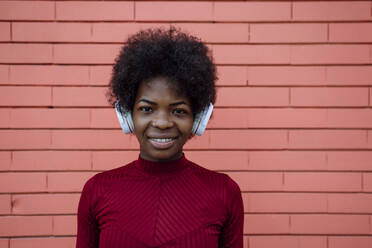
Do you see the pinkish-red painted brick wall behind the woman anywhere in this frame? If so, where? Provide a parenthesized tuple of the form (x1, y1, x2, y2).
(0, 0, 372, 248)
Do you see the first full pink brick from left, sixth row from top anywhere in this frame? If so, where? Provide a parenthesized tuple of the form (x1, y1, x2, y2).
(10, 108, 90, 128)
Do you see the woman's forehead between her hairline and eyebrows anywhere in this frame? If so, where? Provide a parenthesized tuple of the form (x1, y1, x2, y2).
(136, 77, 188, 102)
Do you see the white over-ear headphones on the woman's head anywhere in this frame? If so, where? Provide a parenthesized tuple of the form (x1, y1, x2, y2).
(115, 101, 213, 136)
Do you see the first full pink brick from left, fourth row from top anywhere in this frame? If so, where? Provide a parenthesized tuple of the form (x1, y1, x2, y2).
(9, 65, 90, 85)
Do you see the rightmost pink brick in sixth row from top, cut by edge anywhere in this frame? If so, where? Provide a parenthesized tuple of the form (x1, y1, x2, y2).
(327, 109, 372, 128)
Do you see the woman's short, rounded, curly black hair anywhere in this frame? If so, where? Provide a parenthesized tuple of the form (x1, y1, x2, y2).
(107, 26, 217, 114)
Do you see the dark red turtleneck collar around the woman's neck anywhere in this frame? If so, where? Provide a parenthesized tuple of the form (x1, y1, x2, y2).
(135, 154, 188, 176)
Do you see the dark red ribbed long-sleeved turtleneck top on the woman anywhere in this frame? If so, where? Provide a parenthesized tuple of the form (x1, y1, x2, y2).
(76, 156, 243, 248)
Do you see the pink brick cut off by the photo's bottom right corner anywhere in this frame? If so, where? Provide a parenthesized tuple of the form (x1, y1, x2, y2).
(328, 236, 372, 248)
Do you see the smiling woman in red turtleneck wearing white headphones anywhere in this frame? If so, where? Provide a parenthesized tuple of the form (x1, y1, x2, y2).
(76, 27, 243, 248)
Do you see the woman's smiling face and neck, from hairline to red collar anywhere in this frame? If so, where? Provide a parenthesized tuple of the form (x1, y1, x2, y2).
(133, 77, 193, 161)
